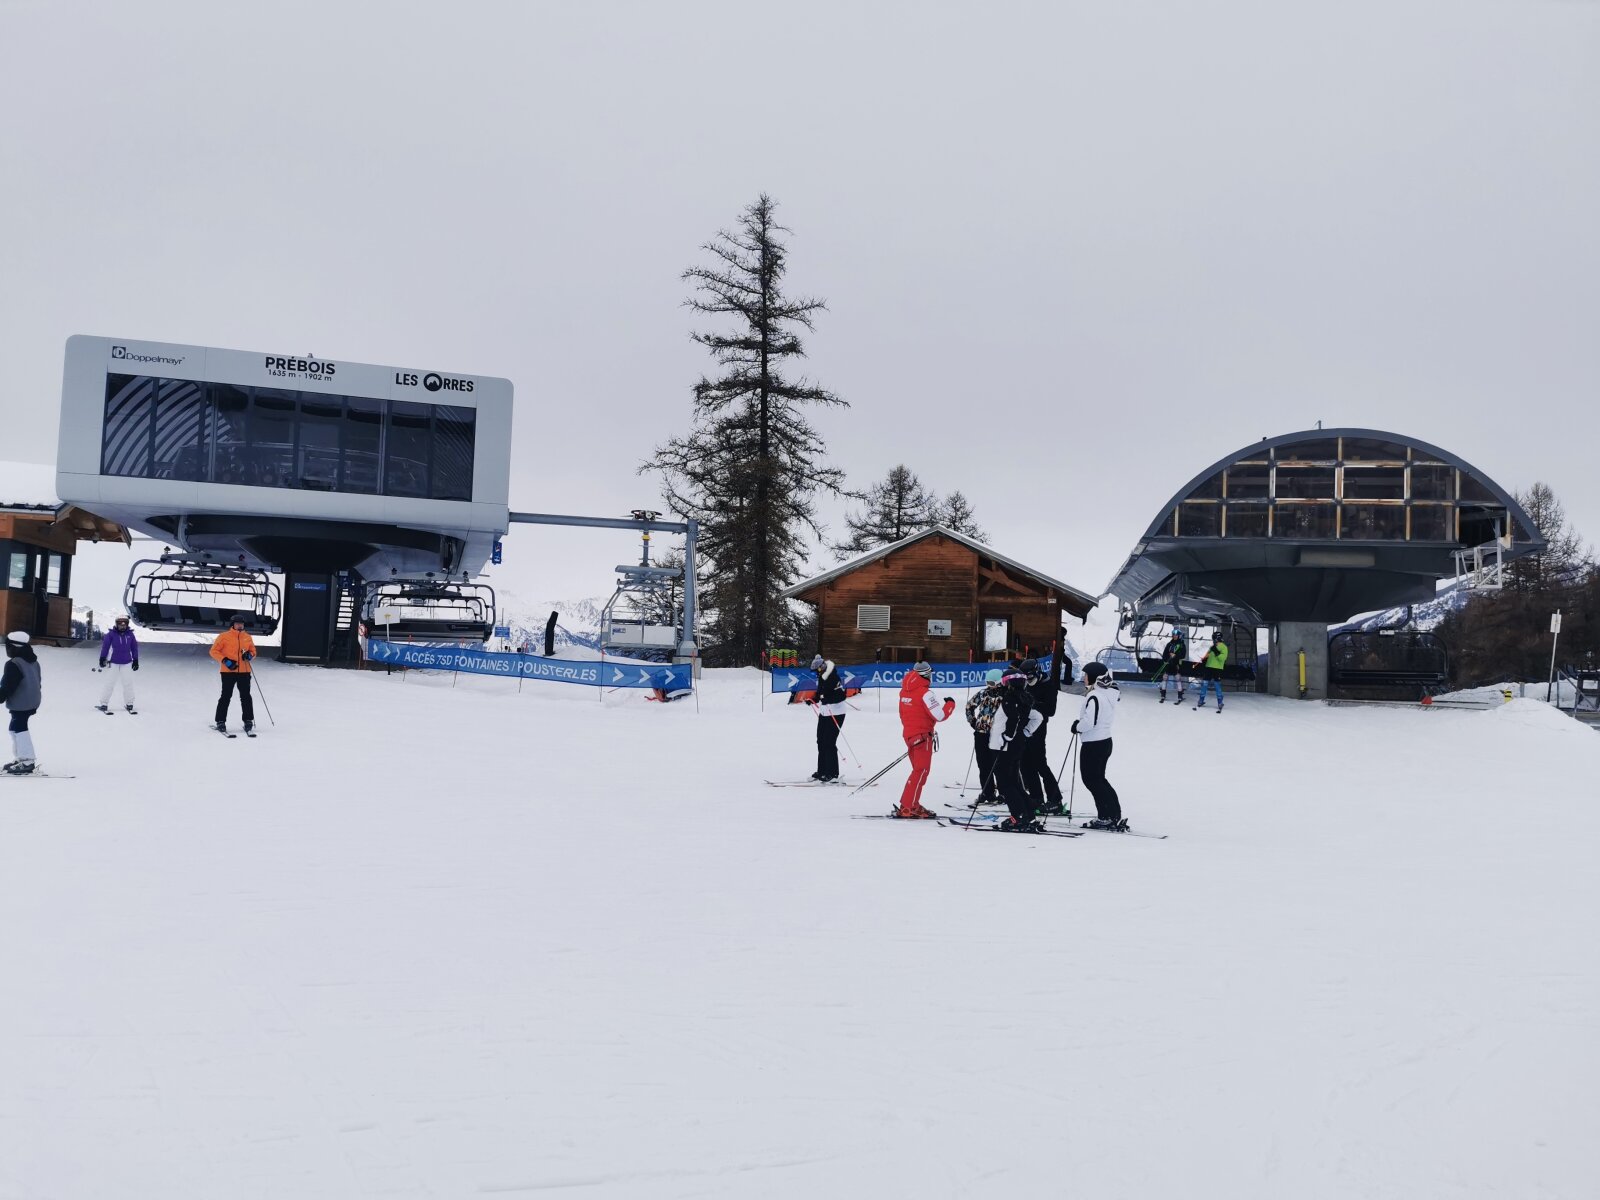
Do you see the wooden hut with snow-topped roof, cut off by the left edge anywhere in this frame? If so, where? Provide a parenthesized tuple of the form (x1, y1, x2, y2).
(0, 462, 133, 642)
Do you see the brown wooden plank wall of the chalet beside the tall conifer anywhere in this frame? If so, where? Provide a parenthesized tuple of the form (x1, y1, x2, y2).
(798, 534, 1061, 662)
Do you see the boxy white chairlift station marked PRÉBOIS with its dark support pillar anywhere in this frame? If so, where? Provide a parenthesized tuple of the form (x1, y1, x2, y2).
(56, 336, 512, 659)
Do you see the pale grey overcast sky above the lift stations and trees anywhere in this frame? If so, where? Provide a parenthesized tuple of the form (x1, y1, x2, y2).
(0, 0, 1600, 620)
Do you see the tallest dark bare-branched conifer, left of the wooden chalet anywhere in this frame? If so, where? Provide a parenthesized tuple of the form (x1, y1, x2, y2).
(640, 194, 846, 666)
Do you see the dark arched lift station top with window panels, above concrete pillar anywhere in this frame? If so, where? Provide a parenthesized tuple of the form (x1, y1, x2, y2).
(1107, 429, 1544, 624)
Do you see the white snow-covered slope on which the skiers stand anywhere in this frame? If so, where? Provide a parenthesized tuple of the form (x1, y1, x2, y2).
(0, 646, 1600, 1200)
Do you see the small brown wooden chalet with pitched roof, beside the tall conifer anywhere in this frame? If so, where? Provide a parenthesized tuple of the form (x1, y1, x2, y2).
(784, 525, 1096, 662)
